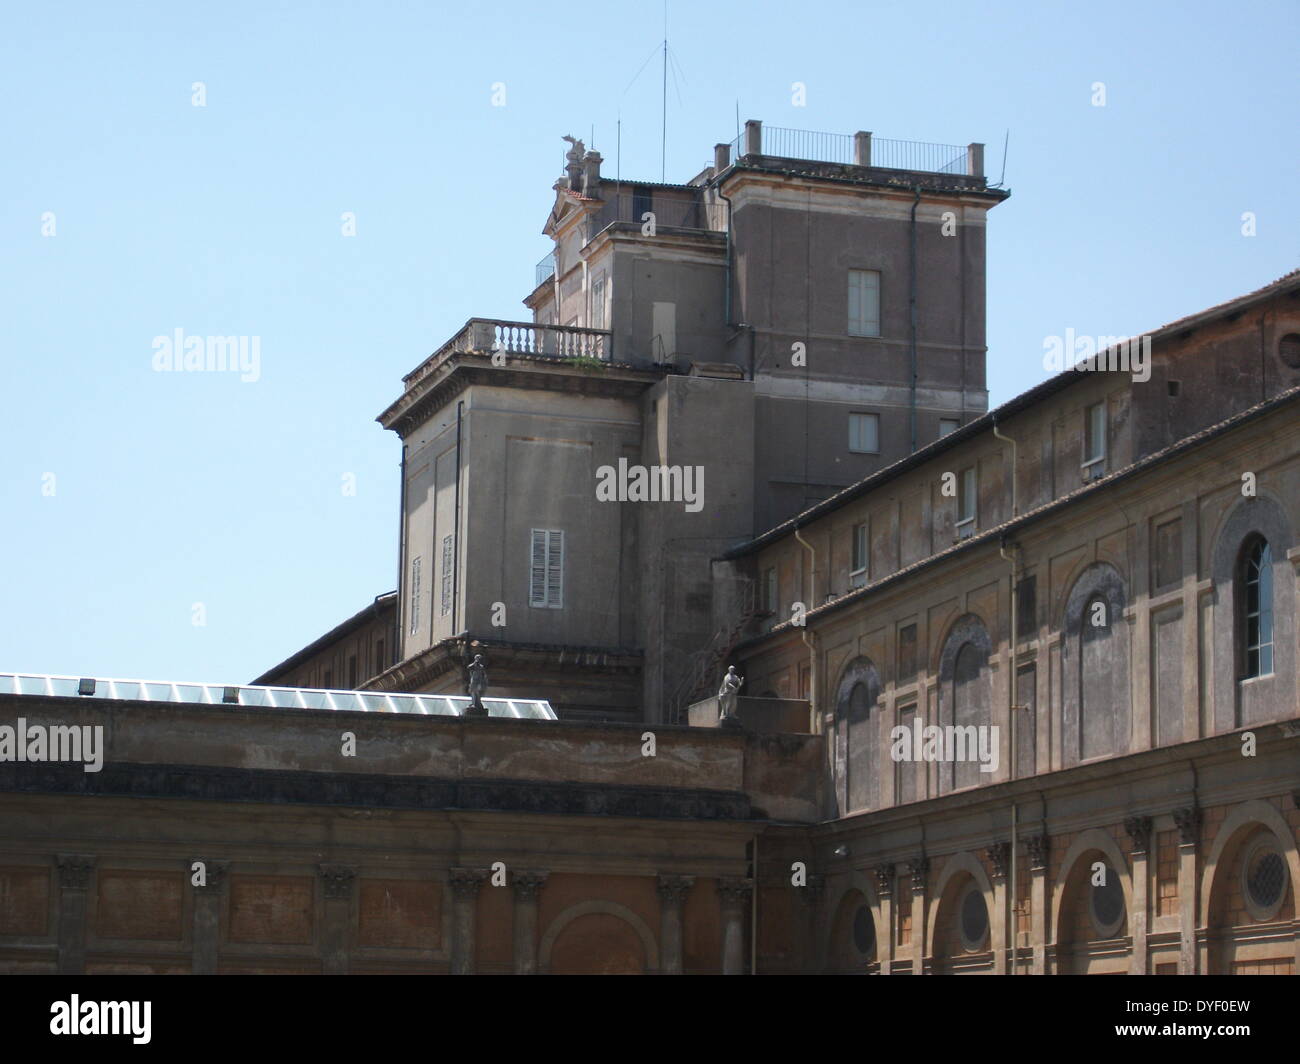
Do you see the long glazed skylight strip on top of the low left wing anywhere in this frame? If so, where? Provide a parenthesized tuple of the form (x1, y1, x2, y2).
(0, 672, 559, 721)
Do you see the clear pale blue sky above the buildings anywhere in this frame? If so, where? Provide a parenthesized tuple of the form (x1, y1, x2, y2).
(0, 0, 1300, 682)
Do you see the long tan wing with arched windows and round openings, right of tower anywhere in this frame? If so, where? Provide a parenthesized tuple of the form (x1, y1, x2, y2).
(722, 273, 1300, 973)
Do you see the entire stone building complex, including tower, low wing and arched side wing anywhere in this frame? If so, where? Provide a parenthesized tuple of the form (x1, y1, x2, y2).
(0, 126, 1300, 974)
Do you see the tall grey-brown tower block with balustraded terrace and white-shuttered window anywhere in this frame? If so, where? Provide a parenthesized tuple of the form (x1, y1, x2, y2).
(274, 122, 1008, 722)
